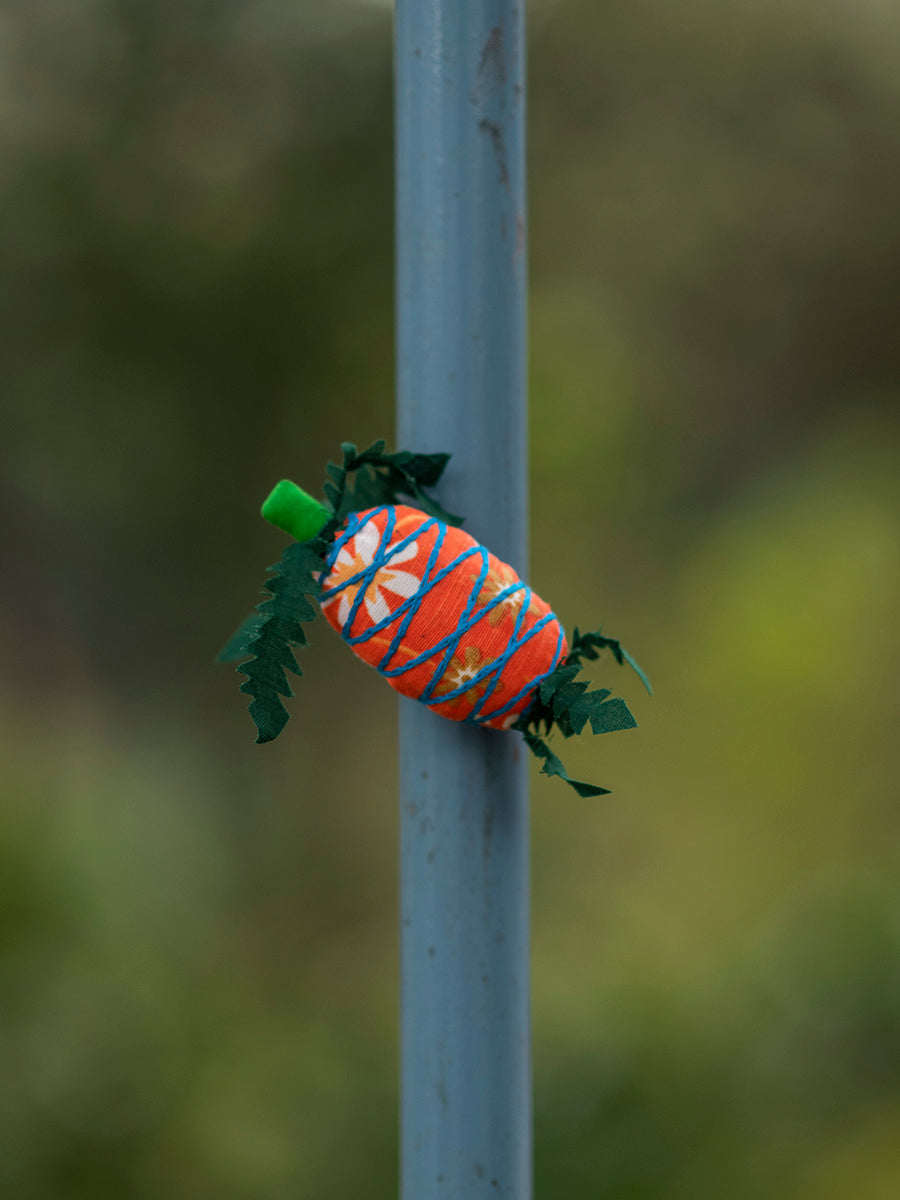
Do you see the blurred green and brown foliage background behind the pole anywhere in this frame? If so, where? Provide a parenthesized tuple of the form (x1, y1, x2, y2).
(0, 0, 900, 1200)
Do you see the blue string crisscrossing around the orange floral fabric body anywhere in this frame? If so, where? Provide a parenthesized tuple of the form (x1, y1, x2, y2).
(319, 504, 563, 725)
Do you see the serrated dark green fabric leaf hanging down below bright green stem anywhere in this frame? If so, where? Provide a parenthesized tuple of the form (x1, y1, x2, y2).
(232, 538, 328, 742)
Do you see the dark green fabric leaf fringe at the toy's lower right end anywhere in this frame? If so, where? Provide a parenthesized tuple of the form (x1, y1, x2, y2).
(512, 629, 650, 797)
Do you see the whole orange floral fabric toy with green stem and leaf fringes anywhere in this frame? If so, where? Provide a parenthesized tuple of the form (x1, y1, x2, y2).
(218, 442, 649, 796)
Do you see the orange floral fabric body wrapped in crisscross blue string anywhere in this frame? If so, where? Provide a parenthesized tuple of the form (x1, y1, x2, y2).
(322, 505, 568, 728)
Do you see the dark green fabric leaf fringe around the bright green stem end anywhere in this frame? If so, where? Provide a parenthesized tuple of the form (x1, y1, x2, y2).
(216, 442, 461, 742)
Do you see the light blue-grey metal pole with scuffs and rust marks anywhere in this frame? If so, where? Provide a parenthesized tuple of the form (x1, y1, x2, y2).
(395, 0, 532, 1200)
